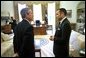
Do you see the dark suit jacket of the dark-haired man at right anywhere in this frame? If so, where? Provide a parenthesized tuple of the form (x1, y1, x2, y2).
(53, 18, 71, 57)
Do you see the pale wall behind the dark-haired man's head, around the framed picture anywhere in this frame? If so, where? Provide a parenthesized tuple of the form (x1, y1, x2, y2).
(60, 1, 80, 23)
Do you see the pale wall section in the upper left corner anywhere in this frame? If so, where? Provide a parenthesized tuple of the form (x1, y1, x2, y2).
(1, 1, 14, 17)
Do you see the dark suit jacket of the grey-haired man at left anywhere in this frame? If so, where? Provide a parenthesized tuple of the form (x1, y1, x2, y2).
(13, 20, 35, 57)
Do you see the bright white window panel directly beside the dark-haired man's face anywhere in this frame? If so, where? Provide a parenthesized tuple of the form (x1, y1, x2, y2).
(48, 2, 55, 35)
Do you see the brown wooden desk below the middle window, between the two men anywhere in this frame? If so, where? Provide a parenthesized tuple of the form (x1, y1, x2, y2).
(34, 26, 46, 35)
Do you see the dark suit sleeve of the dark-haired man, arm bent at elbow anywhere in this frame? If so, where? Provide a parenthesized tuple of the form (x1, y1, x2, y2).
(56, 23, 71, 44)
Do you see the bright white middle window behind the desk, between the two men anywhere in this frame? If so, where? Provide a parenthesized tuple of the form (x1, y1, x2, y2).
(33, 4, 42, 22)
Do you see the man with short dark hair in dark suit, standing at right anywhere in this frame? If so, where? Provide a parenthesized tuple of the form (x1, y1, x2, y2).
(53, 8, 71, 57)
